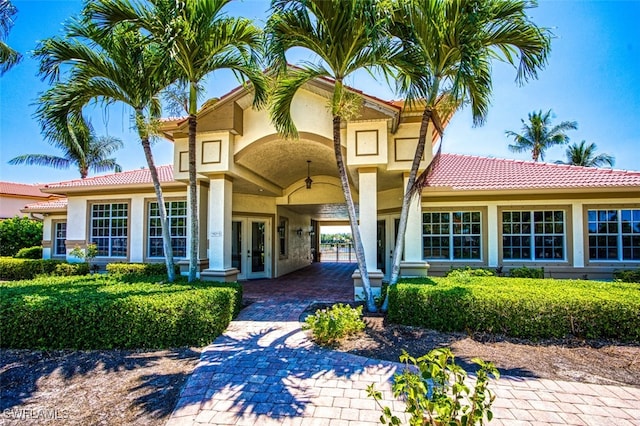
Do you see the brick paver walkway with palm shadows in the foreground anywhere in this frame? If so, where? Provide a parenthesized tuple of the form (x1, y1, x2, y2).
(167, 269, 640, 426)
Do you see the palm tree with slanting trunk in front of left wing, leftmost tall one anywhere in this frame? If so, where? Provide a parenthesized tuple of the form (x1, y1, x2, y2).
(35, 15, 180, 282)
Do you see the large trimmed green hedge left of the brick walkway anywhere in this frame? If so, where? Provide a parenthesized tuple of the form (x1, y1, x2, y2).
(0, 275, 242, 349)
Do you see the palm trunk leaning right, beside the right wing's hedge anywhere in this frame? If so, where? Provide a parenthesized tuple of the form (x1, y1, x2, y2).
(381, 108, 432, 312)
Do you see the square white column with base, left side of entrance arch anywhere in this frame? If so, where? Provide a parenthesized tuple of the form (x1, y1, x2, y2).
(201, 175, 238, 282)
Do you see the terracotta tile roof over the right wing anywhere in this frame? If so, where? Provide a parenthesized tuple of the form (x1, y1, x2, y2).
(426, 154, 640, 190)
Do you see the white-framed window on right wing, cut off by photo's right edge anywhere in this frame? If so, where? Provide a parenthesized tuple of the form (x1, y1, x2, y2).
(587, 209, 640, 261)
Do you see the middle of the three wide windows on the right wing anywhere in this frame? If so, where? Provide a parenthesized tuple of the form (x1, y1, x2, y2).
(502, 210, 565, 260)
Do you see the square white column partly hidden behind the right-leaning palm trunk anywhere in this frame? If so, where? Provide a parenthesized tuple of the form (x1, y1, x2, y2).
(400, 173, 429, 277)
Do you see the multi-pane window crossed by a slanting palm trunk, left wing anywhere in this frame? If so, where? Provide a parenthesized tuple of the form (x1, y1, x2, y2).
(147, 201, 187, 257)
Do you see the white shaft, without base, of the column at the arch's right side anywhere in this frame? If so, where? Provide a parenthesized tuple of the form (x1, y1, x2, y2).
(358, 167, 378, 271)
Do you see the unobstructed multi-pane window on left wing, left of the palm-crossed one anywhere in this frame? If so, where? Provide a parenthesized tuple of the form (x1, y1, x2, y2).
(90, 203, 129, 257)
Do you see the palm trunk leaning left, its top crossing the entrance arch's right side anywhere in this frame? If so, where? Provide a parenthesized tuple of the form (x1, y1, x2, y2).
(333, 115, 377, 312)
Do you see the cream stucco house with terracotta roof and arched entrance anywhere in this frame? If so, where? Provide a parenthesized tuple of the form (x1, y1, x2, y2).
(24, 80, 640, 294)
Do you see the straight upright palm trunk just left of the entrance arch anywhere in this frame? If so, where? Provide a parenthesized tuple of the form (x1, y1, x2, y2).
(189, 83, 200, 282)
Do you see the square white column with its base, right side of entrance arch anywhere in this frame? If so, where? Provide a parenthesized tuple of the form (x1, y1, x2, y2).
(352, 167, 384, 300)
